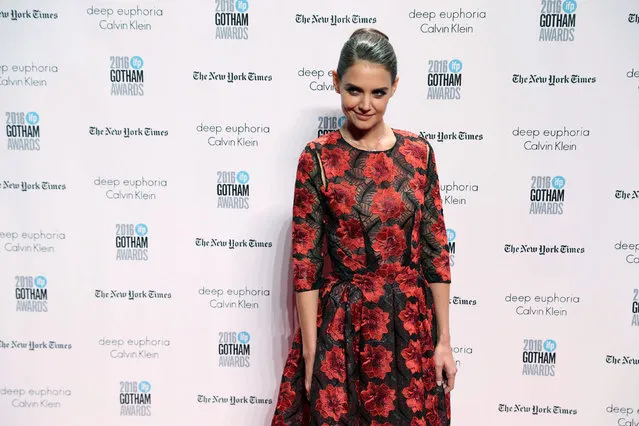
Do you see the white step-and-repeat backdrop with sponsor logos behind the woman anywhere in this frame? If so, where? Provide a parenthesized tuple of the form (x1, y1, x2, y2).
(0, 0, 639, 426)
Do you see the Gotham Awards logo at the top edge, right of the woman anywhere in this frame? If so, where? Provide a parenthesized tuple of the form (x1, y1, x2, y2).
(539, 0, 577, 42)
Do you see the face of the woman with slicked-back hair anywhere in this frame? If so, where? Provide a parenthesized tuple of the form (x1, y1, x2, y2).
(333, 61, 399, 131)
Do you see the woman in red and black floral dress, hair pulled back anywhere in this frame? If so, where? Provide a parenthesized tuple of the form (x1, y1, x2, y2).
(273, 29, 457, 426)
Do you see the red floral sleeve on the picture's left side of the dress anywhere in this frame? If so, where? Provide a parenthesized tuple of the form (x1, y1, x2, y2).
(292, 145, 325, 292)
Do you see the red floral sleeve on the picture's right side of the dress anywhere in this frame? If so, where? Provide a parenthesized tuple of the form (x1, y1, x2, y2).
(420, 142, 451, 284)
